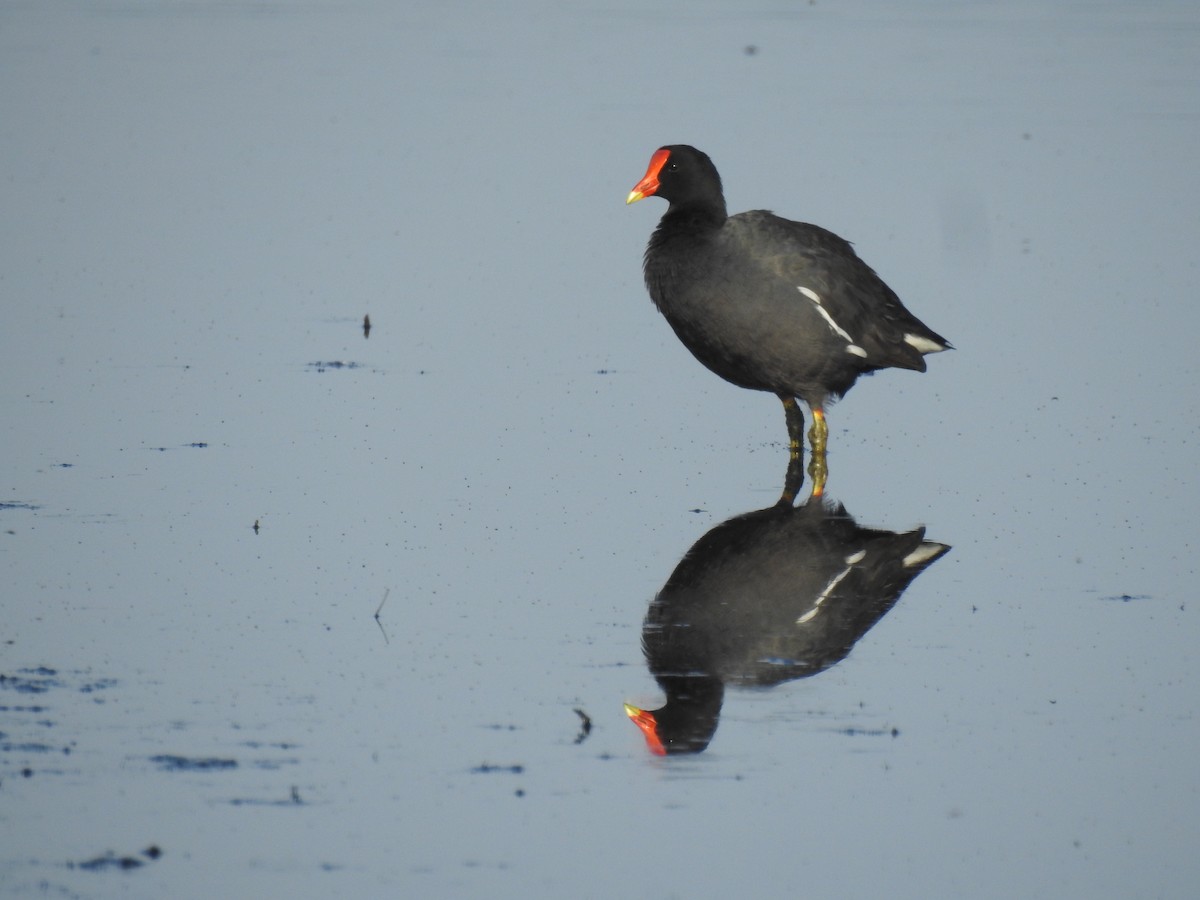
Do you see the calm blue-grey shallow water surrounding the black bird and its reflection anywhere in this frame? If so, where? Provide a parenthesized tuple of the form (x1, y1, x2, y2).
(0, 0, 1200, 898)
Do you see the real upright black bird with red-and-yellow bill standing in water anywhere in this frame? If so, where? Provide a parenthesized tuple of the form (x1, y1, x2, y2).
(625, 144, 952, 497)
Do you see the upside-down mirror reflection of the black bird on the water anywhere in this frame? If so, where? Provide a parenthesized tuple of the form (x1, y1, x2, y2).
(625, 491, 949, 755)
